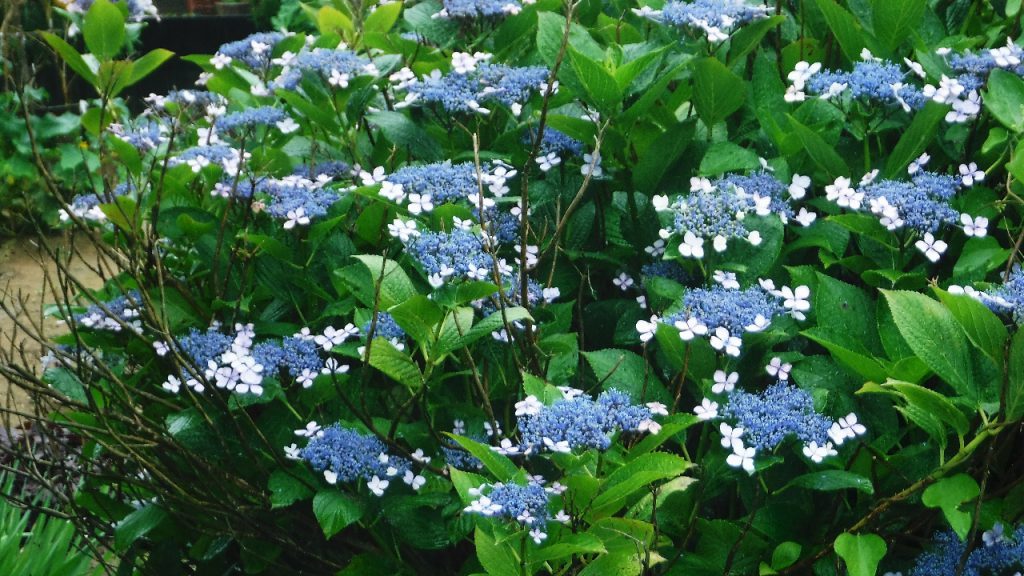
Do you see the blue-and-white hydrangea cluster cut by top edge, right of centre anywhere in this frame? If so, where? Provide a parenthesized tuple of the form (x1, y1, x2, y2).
(647, 0, 768, 42)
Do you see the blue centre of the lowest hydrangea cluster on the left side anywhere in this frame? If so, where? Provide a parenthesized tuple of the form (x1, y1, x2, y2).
(300, 424, 410, 482)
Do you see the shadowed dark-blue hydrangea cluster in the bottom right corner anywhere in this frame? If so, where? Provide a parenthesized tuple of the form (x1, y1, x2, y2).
(910, 524, 1024, 576)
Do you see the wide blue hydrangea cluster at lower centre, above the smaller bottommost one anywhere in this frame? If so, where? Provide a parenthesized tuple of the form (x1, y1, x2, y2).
(512, 388, 663, 454)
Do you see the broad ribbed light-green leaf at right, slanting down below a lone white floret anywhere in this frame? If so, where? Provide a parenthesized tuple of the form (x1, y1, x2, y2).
(882, 290, 981, 403)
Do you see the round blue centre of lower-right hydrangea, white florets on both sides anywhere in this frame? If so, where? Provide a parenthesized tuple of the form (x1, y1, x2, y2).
(722, 382, 833, 452)
